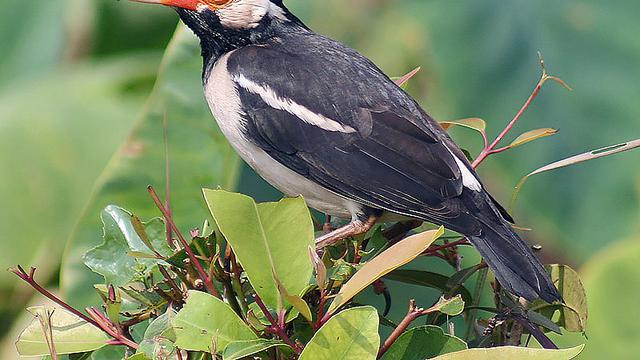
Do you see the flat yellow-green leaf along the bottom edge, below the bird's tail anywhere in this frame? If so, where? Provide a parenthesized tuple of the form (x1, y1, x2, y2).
(433, 345, 584, 360)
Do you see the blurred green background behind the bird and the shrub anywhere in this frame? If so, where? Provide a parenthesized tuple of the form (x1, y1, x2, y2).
(0, 0, 640, 359)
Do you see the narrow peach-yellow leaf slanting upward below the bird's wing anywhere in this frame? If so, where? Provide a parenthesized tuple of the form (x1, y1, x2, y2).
(327, 227, 444, 314)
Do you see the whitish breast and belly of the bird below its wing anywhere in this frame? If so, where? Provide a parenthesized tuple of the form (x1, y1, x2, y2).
(205, 52, 361, 218)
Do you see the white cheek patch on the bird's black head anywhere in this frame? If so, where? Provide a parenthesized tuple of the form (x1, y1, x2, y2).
(216, 0, 287, 29)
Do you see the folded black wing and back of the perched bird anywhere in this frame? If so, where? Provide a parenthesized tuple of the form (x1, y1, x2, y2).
(228, 35, 477, 233)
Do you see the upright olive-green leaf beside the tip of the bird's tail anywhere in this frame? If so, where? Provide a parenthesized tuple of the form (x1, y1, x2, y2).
(531, 264, 588, 332)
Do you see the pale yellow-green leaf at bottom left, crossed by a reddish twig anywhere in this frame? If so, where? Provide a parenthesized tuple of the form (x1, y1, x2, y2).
(16, 306, 110, 356)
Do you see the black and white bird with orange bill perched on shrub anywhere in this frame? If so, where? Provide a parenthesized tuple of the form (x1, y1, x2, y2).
(132, 0, 562, 303)
